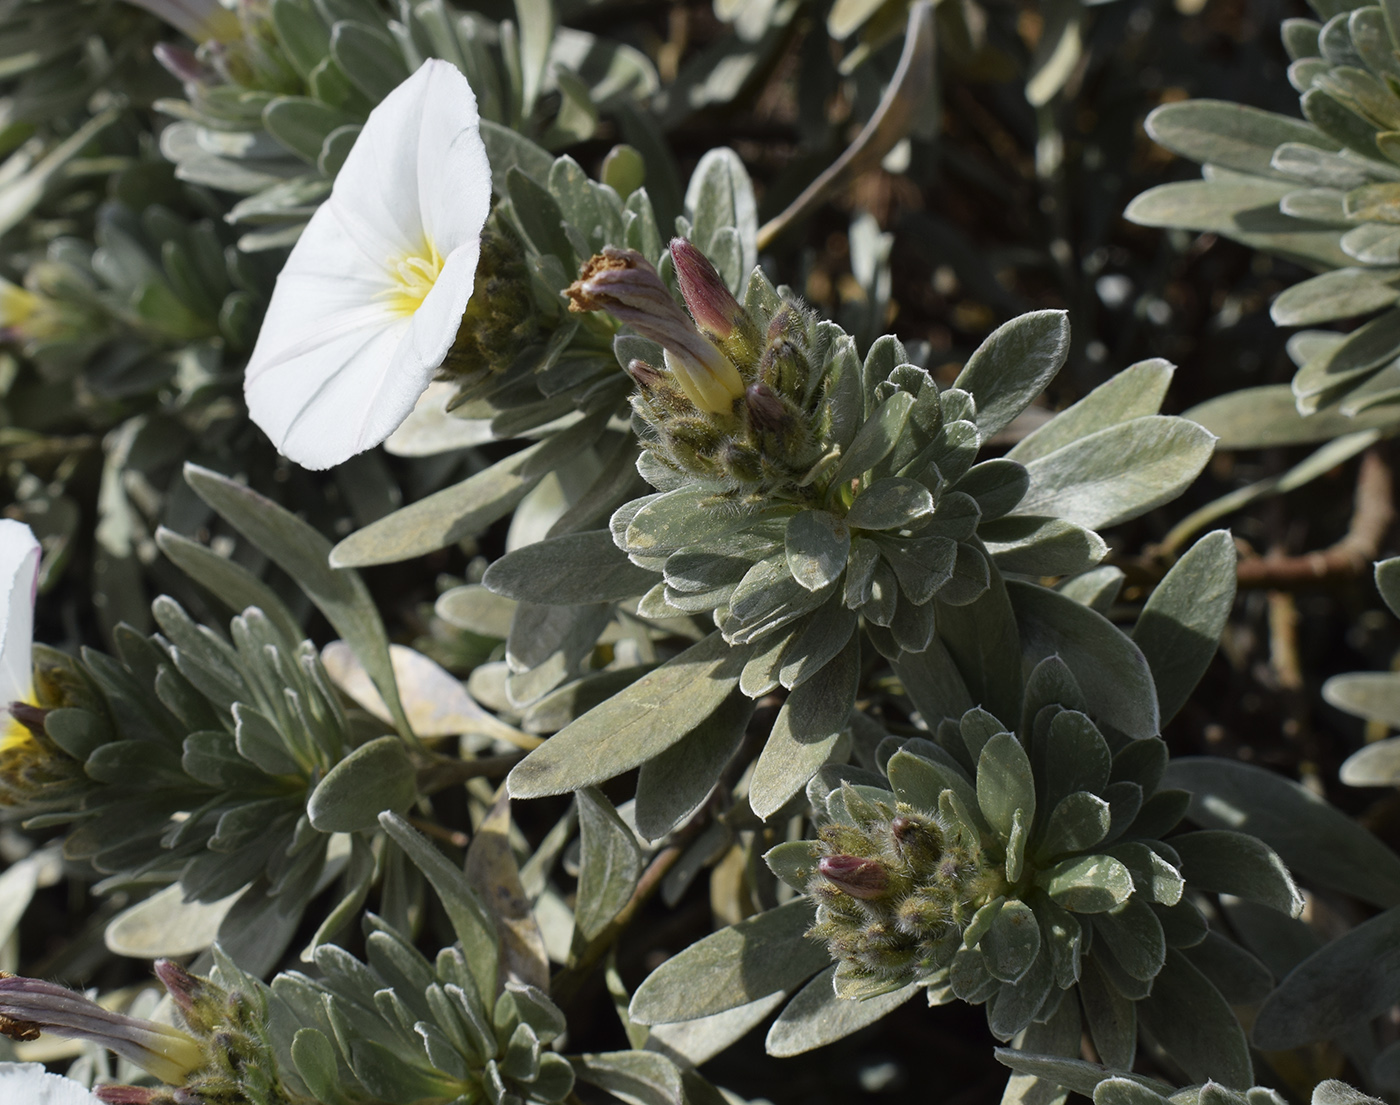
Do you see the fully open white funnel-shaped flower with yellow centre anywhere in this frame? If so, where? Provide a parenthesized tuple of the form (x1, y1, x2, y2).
(244, 60, 491, 468)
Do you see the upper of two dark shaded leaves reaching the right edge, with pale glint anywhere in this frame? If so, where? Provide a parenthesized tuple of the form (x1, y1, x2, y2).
(1163, 756, 1400, 908)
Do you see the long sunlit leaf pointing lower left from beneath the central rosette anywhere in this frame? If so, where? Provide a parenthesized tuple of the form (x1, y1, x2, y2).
(508, 633, 749, 798)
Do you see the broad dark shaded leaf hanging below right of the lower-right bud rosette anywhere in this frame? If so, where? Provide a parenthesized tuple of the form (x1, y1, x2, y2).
(1137, 948, 1259, 1090)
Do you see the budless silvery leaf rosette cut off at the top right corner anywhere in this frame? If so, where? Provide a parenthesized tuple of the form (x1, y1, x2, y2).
(1126, 4, 1400, 425)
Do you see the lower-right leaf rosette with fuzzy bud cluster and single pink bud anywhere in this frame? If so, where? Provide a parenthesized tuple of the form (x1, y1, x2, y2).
(764, 657, 1302, 1053)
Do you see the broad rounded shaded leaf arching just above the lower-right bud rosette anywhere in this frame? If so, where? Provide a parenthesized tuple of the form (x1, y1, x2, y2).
(1007, 583, 1159, 738)
